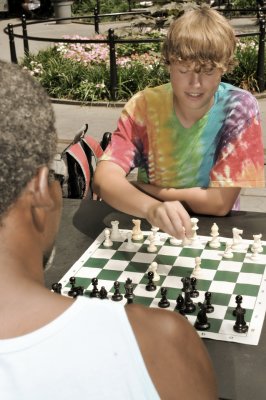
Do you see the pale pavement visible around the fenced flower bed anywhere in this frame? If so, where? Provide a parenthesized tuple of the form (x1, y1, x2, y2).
(0, 13, 266, 212)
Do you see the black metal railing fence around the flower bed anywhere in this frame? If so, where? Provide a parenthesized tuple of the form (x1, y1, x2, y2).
(4, 7, 266, 101)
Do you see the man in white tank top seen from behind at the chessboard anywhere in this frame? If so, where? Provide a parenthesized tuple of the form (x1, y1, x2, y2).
(0, 61, 217, 400)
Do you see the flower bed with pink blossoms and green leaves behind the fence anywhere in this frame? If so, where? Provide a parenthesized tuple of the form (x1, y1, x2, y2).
(22, 35, 258, 101)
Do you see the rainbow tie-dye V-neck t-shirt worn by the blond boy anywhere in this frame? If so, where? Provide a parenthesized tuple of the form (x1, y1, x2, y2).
(101, 83, 264, 188)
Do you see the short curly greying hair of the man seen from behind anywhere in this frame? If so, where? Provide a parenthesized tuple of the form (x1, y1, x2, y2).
(0, 61, 56, 220)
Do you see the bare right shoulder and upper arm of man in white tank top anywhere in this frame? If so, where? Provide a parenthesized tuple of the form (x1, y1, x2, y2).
(126, 304, 217, 400)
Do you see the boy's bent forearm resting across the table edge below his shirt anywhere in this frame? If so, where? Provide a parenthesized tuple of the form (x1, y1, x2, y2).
(135, 182, 240, 216)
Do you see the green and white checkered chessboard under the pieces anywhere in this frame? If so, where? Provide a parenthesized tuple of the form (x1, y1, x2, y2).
(60, 229, 266, 345)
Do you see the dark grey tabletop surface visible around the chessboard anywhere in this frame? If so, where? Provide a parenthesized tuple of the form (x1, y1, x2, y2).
(46, 199, 266, 400)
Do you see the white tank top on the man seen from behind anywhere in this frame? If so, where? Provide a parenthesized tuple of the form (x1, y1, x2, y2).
(0, 297, 159, 400)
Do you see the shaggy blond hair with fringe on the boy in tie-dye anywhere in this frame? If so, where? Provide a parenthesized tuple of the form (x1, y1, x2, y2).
(162, 4, 236, 72)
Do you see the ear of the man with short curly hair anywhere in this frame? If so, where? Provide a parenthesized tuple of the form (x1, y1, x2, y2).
(28, 166, 54, 208)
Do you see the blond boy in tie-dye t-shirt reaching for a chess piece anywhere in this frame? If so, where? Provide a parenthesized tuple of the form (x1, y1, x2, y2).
(94, 5, 264, 237)
